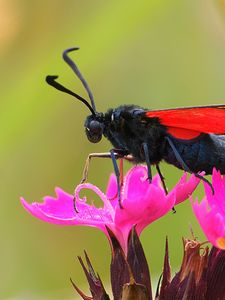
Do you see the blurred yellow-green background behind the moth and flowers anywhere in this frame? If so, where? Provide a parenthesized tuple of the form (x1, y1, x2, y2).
(0, 0, 225, 299)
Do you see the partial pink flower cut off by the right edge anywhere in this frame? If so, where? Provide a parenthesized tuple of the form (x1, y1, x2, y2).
(192, 169, 225, 249)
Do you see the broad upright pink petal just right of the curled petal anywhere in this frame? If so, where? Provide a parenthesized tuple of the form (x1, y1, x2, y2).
(115, 166, 176, 251)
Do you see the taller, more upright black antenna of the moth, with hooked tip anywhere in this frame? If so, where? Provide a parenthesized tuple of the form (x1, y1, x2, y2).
(63, 47, 96, 112)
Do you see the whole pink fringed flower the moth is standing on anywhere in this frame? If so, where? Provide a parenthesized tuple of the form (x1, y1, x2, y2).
(21, 166, 199, 253)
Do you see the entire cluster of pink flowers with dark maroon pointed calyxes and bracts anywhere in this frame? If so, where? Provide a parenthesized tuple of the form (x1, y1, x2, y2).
(21, 166, 225, 300)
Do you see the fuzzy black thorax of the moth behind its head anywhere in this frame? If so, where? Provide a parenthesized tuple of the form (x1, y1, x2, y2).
(104, 105, 165, 164)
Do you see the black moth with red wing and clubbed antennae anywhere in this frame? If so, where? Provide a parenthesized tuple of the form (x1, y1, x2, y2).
(46, 47, 225, 206)
